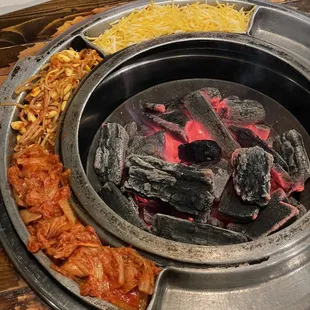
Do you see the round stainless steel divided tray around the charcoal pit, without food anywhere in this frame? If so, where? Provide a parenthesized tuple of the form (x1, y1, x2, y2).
(0, 1, 310, 309)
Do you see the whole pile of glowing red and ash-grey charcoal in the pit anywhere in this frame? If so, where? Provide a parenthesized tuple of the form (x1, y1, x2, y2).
(94, 88, 310, 245)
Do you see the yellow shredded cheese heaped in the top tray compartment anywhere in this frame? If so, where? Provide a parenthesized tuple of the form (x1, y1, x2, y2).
(90, 2, 254, 54)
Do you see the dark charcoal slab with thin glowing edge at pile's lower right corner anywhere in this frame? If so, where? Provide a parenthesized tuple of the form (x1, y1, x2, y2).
(241, 191, 299, 240)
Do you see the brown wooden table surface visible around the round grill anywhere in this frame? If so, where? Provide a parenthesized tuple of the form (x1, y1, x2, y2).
(0, 0, 310, 310)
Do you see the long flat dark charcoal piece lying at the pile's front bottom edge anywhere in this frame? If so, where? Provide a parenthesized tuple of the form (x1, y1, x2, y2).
(152, 214, 247, 245)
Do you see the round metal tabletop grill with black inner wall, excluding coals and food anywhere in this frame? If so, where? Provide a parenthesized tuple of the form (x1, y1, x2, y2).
(0, 1, 310, 310)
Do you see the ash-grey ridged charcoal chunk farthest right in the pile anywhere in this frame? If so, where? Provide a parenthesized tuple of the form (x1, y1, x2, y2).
(273, 129, 310, 186)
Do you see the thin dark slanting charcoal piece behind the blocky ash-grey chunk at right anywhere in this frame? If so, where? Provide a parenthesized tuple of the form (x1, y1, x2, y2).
(229, 126, 288, 171)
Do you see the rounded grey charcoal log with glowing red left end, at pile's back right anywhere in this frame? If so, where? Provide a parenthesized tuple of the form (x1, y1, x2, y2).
(217, 97, 266, 124)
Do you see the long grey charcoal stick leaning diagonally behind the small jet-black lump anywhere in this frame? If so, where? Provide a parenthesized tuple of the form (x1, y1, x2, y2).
(183, 91, 240, 159)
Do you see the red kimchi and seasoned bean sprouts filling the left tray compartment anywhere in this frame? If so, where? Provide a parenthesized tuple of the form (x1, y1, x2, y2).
(8, 49, 160, 310)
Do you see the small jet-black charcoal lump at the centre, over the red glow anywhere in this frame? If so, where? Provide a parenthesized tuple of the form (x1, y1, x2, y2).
(178, 140, 222, 163)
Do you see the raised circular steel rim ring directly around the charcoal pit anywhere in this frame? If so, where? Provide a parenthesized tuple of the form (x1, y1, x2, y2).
(61, 33, 310, 265)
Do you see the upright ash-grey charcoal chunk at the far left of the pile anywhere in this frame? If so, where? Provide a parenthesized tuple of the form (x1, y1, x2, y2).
(94, 123, 129, 185)
